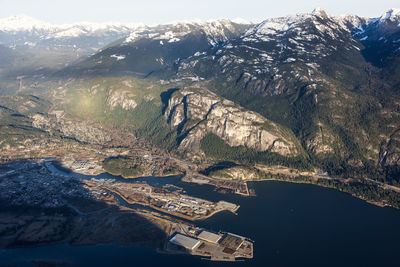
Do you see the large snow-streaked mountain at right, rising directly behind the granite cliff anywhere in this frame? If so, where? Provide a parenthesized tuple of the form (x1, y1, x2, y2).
(165, 9, 400, 170)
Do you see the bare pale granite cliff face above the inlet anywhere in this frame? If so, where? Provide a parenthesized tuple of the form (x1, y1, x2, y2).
(164, 88, 300, 157)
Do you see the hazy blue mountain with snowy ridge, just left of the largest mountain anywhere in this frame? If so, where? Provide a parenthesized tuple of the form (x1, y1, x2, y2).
(65, 20, 251, 76)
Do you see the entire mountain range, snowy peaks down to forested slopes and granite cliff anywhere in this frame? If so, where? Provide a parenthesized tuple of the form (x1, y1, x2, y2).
(0, 8, 400, 188)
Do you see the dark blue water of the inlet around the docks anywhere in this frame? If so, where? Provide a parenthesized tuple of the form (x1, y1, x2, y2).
(0, 169, 400, 267)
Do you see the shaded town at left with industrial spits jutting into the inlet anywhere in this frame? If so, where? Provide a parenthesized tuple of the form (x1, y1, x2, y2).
(0, 159, 253, 261)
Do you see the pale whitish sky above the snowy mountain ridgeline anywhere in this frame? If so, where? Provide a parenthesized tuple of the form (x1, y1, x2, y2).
(0, 0, 400, 25)
